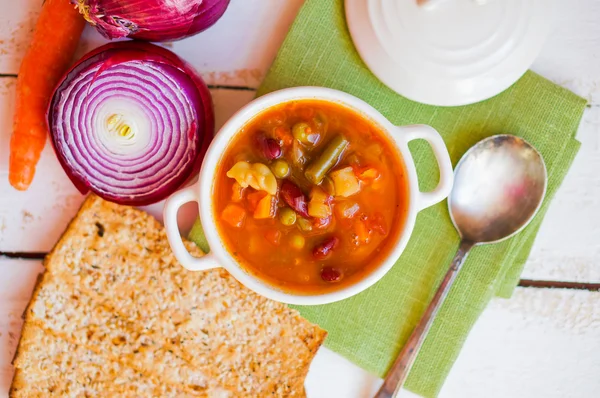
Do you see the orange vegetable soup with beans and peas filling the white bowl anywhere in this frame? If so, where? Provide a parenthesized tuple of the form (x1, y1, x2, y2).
(213, 100, 408, 294)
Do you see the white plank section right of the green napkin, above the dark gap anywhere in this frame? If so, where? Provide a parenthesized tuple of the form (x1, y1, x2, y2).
(523, 104, 600, 282)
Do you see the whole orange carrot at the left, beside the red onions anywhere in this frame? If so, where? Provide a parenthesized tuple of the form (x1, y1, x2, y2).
(8, 0, 85, 191)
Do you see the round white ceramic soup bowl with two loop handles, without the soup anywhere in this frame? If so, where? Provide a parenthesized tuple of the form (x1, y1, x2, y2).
(164, 87, 453, 305)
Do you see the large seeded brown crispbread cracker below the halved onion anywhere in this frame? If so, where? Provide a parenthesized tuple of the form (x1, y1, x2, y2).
(12, 195, 325, 397)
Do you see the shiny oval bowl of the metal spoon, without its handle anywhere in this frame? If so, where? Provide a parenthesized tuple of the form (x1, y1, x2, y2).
(448, 135, 547, 243)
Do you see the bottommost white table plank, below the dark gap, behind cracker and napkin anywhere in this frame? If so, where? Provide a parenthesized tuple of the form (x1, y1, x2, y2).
(0, 258, 600, 398)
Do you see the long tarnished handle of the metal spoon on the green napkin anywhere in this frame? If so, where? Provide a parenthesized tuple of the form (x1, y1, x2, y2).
(374, 240, 473, 398)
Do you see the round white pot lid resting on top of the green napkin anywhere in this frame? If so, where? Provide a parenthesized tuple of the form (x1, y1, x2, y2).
(345, 0, 555, 106)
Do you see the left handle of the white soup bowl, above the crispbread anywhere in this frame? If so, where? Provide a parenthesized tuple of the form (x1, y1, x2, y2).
(163, 184, 220, 271)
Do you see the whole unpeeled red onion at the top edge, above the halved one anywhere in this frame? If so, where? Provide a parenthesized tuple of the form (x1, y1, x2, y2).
(71, 0, 229, 42)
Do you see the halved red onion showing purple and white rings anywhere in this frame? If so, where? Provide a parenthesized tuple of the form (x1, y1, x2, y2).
(48, 41, 214, 206)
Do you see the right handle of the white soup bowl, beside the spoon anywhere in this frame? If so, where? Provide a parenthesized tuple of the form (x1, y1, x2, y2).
(394, 124, 454, 211)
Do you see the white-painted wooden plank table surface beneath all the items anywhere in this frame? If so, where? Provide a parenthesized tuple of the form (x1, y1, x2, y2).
(0, 0, 600, 398)
